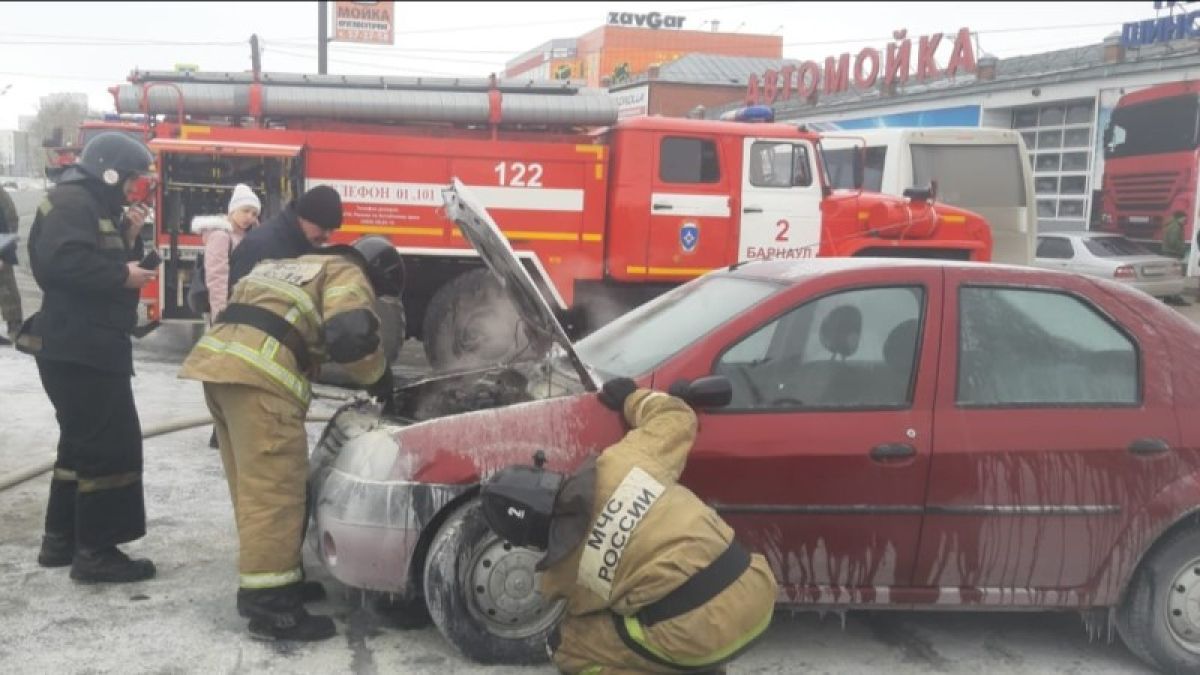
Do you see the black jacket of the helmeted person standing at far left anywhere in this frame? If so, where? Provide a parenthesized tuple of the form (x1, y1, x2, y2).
(29, 180, 142, 375)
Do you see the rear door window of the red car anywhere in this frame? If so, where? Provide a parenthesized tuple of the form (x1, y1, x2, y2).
(956, 287, 1140, 406)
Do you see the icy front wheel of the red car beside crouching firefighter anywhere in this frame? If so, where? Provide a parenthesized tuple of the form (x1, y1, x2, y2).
(425, 498, 565, 665)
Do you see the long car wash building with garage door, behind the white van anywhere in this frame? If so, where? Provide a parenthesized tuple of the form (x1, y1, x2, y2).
(734, 14, 1200, 238)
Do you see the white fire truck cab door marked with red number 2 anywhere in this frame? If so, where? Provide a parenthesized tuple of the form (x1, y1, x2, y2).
(738, 138, 822, 261)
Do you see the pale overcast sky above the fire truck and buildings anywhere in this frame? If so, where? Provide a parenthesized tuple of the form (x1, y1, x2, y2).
(0, 0, 1156, 129)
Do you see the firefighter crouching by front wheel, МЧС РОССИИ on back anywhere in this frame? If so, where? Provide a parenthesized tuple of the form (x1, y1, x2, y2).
(482, 378, 776, 674)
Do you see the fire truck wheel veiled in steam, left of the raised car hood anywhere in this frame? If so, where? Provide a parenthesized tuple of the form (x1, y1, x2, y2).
(425, 269, 529, 370)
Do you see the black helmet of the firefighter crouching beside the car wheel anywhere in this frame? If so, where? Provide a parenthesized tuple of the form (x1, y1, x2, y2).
(480, 466, 563, 550)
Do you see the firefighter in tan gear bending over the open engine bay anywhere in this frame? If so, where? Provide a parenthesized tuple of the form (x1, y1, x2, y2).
(180, 234, 403, 640)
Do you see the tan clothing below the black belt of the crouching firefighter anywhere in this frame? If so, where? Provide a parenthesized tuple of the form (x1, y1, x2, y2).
(547, 554, 778, 675)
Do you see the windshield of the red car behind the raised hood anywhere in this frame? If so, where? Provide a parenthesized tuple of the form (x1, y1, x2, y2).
(575, 274, 782, 380)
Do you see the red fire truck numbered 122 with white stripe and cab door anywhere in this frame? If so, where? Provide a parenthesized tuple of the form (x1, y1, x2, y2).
(112, 72, 991, 368)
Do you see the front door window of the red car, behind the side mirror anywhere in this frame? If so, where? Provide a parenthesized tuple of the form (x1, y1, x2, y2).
(714, 286, 925, 411)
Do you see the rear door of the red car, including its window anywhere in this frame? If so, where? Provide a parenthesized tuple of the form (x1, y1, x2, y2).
(916, 268, 1180, 598)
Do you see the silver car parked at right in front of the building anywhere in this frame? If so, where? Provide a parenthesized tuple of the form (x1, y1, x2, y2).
(1033, 232, 1184, 298)
